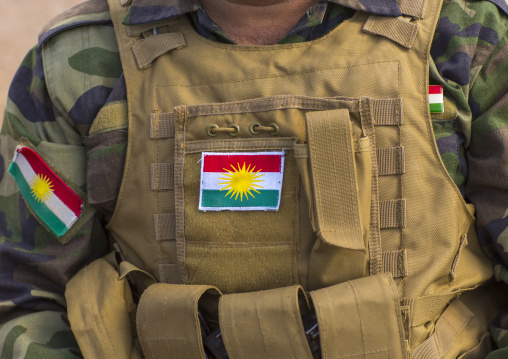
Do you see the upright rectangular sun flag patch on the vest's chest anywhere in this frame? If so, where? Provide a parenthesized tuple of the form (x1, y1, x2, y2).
(199, 152, 284, 211)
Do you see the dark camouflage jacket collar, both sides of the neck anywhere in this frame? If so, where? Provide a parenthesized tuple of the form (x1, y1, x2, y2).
(123, 0, 401, 25)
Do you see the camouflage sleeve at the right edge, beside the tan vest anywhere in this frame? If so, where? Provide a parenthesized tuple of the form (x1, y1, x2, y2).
(450, 0, 508, 359)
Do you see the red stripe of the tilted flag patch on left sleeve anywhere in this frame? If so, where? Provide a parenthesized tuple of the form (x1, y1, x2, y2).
(17, 147, 83, 217)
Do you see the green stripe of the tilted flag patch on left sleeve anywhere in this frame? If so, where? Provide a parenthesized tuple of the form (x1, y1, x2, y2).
(9, 162, 68, 237)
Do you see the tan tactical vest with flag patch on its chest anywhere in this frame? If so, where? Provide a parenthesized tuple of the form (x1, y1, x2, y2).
(103, 0, 492, 357)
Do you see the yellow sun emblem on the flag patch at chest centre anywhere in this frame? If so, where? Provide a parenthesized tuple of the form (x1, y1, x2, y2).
(219, 162, 264, 201)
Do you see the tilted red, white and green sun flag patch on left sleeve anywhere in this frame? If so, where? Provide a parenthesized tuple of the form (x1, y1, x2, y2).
(9, 146, 83, 237)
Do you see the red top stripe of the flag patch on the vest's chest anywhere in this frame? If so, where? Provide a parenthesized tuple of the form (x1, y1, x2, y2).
(203, 155, 281, 172)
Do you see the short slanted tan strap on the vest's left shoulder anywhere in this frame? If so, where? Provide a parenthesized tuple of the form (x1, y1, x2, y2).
(132, 32, 185, 70)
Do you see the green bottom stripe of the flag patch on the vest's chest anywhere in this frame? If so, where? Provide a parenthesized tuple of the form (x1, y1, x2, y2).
(201, 190, 279, 208)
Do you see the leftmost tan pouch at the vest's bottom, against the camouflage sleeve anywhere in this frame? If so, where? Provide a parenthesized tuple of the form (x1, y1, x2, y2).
(65, 254, 143, 359)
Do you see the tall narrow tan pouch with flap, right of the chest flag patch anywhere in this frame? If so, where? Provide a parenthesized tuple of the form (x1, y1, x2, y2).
(304, 109, 373, 288)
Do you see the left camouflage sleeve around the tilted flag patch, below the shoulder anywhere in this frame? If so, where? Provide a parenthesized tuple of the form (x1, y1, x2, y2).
(0, 48, 108, 359)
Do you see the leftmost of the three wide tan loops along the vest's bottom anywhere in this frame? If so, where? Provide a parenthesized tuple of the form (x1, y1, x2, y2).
(136, 284, 220, 359)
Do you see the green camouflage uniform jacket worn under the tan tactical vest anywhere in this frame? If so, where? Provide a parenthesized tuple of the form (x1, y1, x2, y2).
(0, 0, 508, 359)
